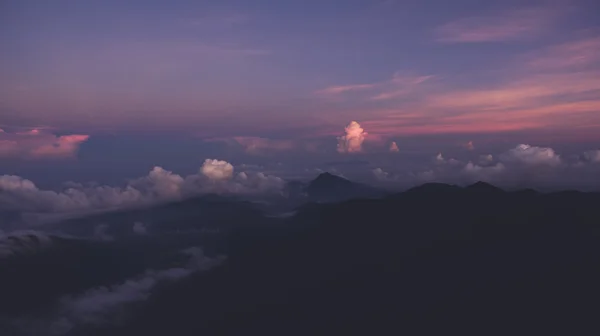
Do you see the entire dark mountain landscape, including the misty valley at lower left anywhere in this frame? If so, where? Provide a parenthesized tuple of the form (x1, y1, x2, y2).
(0, 174, 600, 335)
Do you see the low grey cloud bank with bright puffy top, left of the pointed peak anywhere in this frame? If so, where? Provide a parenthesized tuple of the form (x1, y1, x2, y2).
(0, 159, 285, 217)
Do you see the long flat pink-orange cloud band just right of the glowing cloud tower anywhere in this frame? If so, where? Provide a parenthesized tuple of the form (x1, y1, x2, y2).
(342, 91, 600, 137)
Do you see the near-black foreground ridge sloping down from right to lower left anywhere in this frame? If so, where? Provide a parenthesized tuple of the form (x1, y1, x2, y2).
(3, 182, 600, 336)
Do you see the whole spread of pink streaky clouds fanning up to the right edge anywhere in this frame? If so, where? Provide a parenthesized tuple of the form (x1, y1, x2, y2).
(318, 32, 600, 139)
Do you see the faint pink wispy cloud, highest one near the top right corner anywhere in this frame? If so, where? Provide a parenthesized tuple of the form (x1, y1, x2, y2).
(435, 8, 559, 43)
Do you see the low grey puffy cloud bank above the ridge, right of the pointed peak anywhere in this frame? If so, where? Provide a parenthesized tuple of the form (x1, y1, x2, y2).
(372, 144, 600, 191)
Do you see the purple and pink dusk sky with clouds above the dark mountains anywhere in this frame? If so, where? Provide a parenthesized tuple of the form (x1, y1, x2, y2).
(0, 0, 600, 197)
